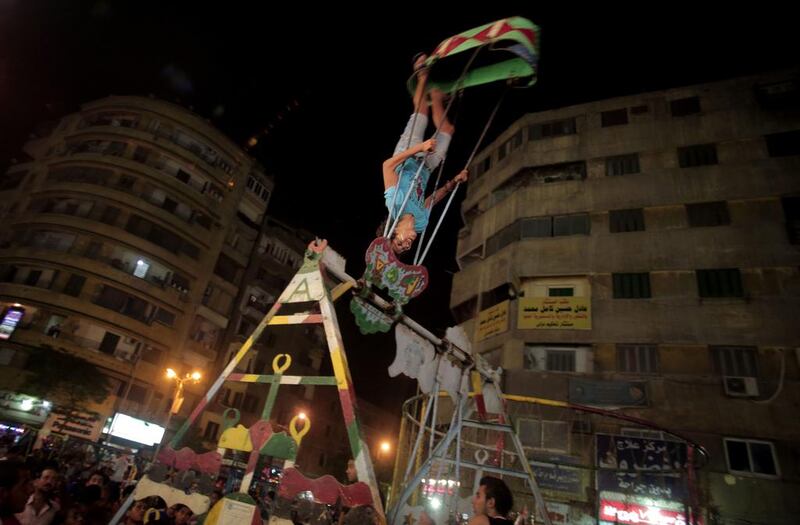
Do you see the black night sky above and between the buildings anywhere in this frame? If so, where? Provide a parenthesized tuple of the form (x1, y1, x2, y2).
(0, 0, 798, 406)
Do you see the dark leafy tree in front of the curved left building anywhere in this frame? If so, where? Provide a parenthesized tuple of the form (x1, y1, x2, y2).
(23, 348, 111, 429)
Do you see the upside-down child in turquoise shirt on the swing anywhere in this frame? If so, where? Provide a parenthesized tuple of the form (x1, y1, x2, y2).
(381, 54, 468, 254)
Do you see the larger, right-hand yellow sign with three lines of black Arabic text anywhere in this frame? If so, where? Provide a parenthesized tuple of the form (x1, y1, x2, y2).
(517, 297, 592, 330)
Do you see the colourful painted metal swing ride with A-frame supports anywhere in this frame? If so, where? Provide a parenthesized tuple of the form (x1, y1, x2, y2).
(111, 17, 702, 525)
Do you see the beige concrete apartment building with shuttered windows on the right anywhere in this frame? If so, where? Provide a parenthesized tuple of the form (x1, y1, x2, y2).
(451, 70, 800, 524)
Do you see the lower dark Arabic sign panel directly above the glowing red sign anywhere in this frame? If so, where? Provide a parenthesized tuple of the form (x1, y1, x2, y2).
(597, 470, 688, 501)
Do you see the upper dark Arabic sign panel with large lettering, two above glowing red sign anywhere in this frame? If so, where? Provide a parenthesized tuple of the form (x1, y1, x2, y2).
(596, 434, 687, 472)
